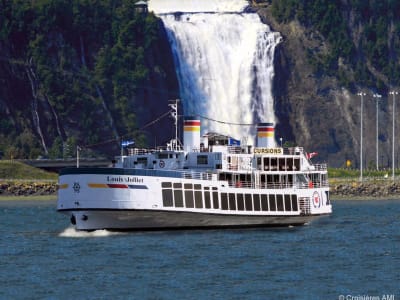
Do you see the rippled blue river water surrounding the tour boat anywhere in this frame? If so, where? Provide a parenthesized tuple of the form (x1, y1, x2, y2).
(0, 200, 400, 300)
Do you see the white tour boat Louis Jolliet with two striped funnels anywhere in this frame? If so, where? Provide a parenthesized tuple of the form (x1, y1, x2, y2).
(57, 106, 332, 230)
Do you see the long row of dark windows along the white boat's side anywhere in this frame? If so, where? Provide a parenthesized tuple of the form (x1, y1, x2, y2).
(162, 182, 298, 212)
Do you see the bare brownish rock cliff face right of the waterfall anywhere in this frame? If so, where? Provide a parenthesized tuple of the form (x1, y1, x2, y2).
(255, 0, 399, 168)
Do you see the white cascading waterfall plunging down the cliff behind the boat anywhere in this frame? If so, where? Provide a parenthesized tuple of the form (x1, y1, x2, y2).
(149, 0, 281, 142)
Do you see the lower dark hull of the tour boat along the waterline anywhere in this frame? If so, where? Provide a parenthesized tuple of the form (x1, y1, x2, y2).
(63, 210, 322, 231)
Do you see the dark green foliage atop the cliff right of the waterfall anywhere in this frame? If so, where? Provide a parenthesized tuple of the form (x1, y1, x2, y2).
(271, 0, 400, 88)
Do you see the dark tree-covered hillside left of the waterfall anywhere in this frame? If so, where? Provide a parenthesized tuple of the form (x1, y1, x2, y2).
(0, 0, 177, 158)
